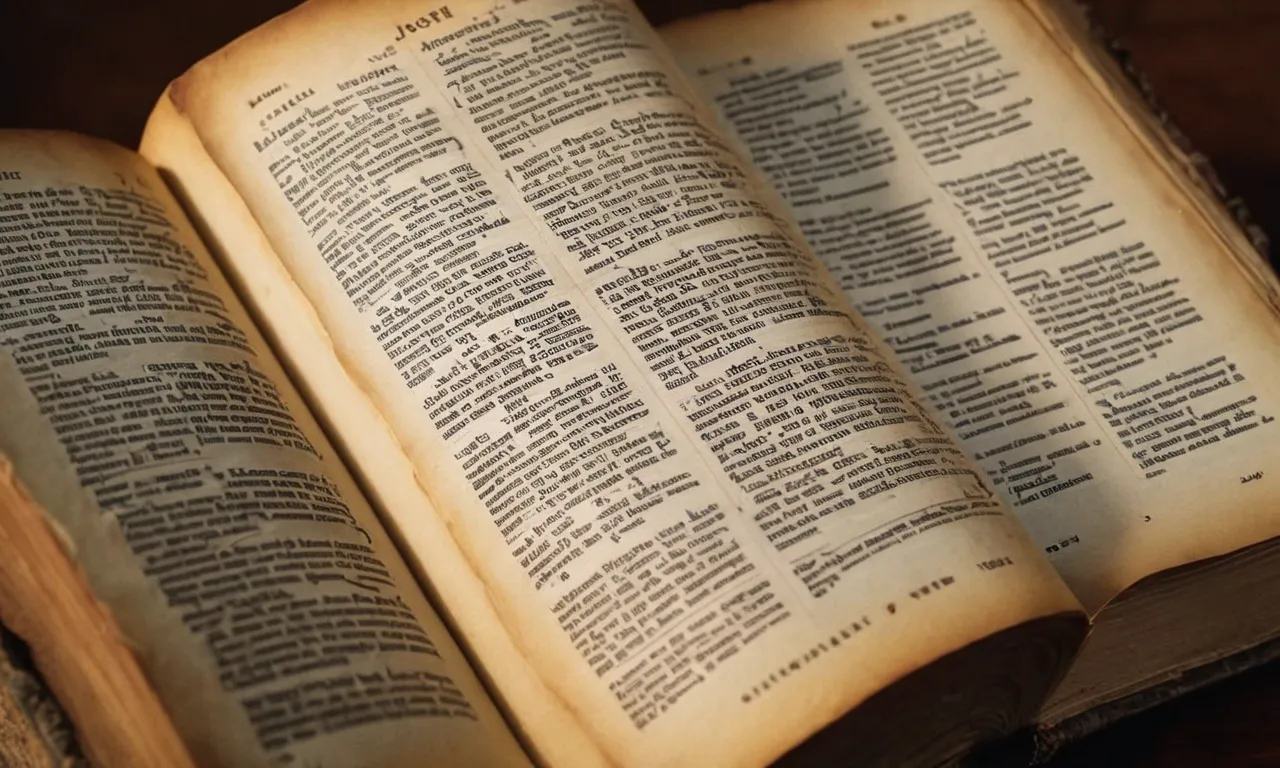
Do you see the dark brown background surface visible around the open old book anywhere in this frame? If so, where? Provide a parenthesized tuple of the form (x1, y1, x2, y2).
(0, 0, 1280, 768)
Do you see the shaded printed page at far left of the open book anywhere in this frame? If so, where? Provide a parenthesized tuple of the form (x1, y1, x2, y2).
(0, 133, 527, 767)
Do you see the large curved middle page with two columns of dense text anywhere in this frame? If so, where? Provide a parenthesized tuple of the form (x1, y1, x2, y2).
(160, 0, 1075, 765)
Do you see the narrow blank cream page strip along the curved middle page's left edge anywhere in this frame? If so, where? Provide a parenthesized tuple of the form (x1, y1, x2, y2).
(140, 92, 607, 765)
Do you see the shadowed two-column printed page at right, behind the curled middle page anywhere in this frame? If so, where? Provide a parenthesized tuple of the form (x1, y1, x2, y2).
(666, 0, 1280, 609)
